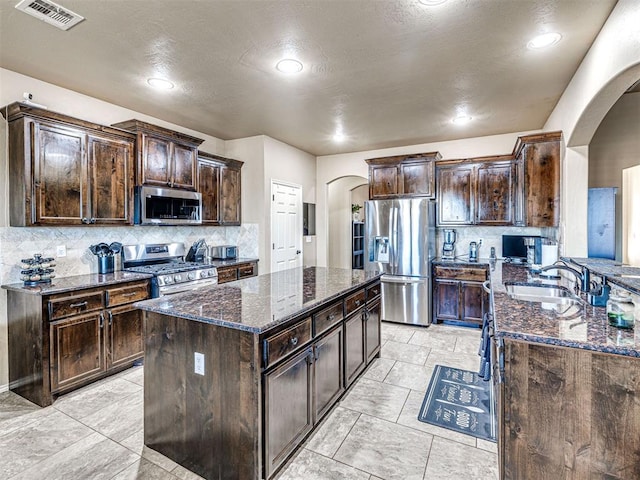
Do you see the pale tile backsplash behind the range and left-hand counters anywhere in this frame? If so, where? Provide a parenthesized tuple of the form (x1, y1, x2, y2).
(0, 224, 258, 284)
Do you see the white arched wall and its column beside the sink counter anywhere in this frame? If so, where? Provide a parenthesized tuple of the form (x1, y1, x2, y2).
(544, 0, 640, 256)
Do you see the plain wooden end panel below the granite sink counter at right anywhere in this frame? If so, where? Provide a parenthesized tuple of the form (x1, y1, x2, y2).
(498, 338, 640, 480)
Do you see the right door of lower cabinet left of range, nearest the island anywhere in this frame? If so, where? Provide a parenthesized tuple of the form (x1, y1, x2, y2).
(106, 305, 144, 369)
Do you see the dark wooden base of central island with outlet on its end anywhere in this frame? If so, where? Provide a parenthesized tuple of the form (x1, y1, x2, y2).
(144, 279, 380, 480)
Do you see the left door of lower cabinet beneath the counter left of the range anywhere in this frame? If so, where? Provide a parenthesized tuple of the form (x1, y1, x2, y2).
(50, 312, 106, 393)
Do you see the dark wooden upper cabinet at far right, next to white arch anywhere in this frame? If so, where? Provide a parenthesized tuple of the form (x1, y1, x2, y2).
(513, 132, 562, 227)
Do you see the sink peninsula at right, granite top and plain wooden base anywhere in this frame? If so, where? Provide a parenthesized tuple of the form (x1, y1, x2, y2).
(490, 262, 640, 480)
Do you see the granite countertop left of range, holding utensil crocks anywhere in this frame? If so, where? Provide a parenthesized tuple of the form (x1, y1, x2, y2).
(2, 271, 153, 295)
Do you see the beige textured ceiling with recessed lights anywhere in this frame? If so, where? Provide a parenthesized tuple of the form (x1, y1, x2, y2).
(0, 0, 615, 155)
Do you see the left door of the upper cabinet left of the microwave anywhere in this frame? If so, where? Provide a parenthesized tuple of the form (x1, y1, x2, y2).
(31, 122, 88, 225)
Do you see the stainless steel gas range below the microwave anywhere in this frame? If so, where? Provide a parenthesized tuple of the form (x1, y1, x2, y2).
(122, 243, 218, 298)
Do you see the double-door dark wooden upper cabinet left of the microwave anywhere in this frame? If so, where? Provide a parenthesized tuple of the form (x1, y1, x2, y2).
(2, 103, 135, 226)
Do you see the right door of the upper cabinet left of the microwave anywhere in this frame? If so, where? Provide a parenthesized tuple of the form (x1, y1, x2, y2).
(83, 136, 135, 224)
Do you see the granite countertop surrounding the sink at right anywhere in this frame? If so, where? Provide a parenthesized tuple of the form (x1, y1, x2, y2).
(490, 261, 640, 357)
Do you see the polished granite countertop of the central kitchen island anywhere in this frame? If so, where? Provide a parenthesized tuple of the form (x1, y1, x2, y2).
(135, 267, 381, 333)
